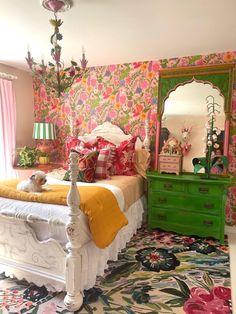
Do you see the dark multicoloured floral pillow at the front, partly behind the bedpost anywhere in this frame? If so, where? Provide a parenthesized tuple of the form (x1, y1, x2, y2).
(63, 151, 99, 183)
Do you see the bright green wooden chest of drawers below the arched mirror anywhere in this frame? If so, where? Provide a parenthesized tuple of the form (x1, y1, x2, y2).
(147, 171, 230, 243)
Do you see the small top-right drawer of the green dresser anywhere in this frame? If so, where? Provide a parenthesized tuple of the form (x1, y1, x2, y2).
(187, 183, 224, 196)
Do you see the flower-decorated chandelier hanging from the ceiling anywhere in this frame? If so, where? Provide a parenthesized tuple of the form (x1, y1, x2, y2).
(25, 0, 88, 97)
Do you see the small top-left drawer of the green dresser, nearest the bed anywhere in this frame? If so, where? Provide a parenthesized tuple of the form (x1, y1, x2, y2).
(149, 179, 185, 192)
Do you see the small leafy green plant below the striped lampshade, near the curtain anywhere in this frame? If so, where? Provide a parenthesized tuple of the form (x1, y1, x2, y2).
(17, 146, 38, 168)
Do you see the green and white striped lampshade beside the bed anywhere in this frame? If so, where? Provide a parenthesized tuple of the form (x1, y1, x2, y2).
(33, 122, 56, 140)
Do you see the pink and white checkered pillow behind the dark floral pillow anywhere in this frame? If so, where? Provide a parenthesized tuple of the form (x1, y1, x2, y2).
(77, 147, 110, 179)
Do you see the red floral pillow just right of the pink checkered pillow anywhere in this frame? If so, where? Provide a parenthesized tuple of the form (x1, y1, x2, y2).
(114, 137, 137, 176)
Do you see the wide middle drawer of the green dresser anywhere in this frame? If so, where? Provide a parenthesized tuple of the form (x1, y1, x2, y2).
(149, 192, 222, 215)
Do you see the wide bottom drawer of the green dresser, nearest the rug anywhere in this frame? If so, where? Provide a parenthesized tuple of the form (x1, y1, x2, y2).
(148, 208, 222, 239)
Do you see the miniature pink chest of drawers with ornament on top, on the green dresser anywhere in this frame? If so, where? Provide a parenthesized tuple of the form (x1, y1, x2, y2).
(158, 137, 182, 175)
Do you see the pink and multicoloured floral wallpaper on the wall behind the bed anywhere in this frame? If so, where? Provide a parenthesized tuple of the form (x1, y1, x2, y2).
(34, 51, 236, 225)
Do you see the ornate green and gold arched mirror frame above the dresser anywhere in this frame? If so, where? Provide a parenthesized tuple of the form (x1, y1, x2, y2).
(155, 64, 234, 169)
